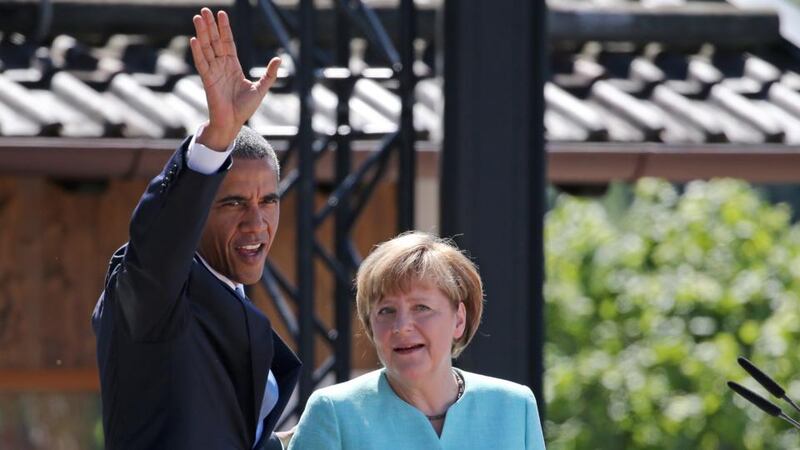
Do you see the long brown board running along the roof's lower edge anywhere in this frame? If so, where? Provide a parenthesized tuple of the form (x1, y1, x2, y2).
(0, 137, 800, 184)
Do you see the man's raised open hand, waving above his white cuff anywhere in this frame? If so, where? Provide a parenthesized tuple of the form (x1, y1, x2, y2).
(189, 8, 281, 151)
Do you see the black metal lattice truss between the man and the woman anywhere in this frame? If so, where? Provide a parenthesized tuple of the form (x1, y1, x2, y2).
(237, 0, 416, 426)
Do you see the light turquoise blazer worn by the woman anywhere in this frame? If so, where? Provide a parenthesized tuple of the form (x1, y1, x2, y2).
(289, 369, 545, 450)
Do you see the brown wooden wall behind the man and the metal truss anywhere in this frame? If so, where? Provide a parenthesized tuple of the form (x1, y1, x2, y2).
(0, 170, 395, 391)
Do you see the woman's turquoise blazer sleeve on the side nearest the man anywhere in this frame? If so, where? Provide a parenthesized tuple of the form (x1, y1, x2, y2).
(289, 392, 342, 450)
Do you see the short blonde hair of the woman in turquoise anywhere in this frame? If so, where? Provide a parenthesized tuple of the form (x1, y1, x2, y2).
(356, 231, 483, 358)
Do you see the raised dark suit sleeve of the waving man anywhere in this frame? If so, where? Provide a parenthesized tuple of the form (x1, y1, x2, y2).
(111, 139, 231, 340)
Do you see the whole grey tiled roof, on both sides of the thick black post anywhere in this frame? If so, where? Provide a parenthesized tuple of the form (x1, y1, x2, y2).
(0, 0, 800, 180)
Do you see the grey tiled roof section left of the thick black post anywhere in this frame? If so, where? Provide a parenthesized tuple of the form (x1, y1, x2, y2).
(0, 35, 441, 139)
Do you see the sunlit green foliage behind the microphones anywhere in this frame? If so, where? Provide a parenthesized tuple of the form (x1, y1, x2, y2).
(545, 179, 800, 450)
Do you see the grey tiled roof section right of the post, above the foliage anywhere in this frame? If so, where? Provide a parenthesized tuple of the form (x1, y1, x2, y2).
(545, 3, 800, 144)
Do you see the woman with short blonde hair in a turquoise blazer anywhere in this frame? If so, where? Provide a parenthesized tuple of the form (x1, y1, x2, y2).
(289, 232, 544, 450)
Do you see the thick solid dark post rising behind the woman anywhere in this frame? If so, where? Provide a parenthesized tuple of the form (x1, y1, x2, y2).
(440, 0, 547, 418)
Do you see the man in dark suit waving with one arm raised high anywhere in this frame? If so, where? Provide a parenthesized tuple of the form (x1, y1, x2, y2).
(92, 8, 300, 450)
